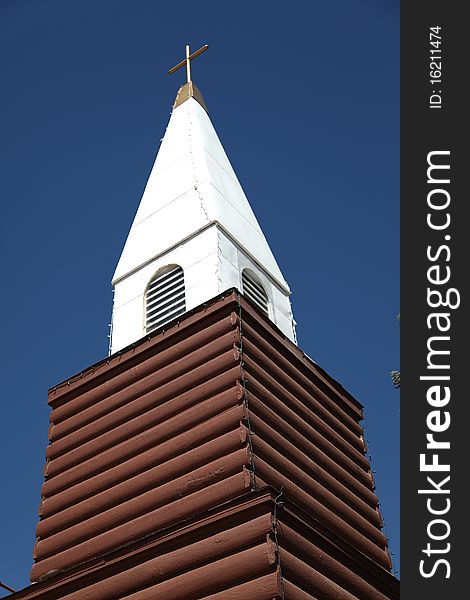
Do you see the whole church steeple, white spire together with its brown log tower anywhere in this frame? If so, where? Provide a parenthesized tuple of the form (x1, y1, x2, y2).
(22, 49, 398, 600)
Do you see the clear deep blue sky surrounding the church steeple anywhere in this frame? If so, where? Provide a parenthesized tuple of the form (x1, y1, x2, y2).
(0, 0, 399, 597)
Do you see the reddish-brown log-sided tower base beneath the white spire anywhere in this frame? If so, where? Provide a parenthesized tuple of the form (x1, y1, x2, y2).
(12, 290, 398, 600)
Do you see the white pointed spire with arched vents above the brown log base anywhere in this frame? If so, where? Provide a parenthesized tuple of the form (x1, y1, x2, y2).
(111, 81, 295, 353)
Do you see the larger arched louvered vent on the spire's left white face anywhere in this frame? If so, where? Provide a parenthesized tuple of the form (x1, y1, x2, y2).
(145, 266, 186, 333)
